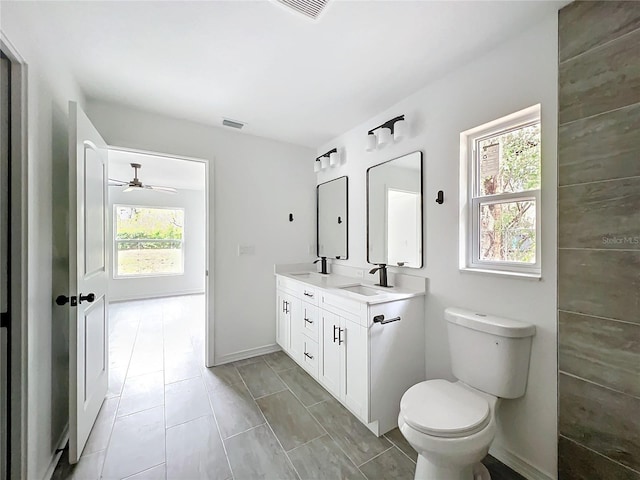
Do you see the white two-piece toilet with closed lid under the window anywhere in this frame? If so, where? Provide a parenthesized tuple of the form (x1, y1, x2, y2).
(398, 308, 536, 480)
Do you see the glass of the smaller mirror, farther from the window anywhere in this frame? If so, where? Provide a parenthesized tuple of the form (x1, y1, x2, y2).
(316, 177, 349, 259)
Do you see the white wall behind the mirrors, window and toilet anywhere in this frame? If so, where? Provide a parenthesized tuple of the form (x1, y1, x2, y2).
(317, 14, 558, 478)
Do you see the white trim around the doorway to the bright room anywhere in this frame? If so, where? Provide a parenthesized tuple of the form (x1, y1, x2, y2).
(107, 145, 215, 367)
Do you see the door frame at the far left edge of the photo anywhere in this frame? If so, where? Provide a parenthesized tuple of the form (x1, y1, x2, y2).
(0, 31, 28, 479)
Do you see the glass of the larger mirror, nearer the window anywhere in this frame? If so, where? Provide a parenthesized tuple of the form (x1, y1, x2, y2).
(367, 152, 423, 268)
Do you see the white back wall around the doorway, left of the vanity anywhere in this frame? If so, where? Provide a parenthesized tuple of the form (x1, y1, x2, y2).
(87, 102, 316, 363)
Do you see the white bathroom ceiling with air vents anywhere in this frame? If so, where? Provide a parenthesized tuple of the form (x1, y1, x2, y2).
(3, 0, 567, 148)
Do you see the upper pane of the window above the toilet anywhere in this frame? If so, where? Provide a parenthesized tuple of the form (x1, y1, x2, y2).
(476, 123, 540, 196)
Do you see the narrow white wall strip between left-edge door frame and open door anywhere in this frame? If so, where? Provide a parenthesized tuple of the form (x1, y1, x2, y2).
(0, 2, 83, 479)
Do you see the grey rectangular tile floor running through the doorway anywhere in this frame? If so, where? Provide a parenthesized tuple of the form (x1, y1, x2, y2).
(53, 296, 523, 480)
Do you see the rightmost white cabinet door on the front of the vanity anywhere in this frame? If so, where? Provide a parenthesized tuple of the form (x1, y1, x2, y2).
(338, 318, 369, 417)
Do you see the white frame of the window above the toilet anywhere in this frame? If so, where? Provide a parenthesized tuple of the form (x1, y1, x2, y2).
(460, 105, 542, 278)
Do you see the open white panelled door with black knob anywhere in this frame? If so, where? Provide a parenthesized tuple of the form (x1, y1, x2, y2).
(69, 102, 109, 463)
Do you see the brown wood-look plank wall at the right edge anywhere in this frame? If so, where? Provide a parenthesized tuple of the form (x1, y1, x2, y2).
(558, 1, 640, 480)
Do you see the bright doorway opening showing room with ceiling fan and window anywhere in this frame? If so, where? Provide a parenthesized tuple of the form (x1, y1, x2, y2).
(103, 147, 213, 398)
